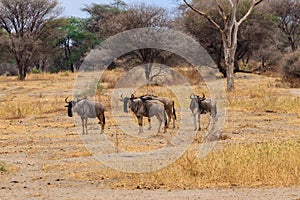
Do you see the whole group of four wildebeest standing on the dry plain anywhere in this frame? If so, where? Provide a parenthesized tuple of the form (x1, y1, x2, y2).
(65, 93, 217, 134)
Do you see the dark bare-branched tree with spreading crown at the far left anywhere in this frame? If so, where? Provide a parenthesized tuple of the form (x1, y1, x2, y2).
(0, 0, 62, 80)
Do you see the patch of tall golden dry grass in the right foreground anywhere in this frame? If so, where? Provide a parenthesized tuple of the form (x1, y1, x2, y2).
(112, 140, 300, 189)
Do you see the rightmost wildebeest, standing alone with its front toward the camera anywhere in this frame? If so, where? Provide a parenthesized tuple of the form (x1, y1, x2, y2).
(190, 93, 217, 130)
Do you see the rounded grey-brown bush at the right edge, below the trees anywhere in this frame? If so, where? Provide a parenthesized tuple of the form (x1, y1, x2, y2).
(281, 50, 300, 87)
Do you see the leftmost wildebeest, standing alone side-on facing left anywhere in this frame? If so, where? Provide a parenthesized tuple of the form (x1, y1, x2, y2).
(65, 97, 105, 134)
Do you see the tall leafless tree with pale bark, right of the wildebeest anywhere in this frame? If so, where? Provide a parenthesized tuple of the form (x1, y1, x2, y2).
(183, 0, 263, 91)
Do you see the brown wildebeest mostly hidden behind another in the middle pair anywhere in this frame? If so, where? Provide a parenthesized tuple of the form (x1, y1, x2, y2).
(120, 95, 176, 128)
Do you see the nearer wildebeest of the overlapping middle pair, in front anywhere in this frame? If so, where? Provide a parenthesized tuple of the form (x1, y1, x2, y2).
(129, 95, 168, 133)
